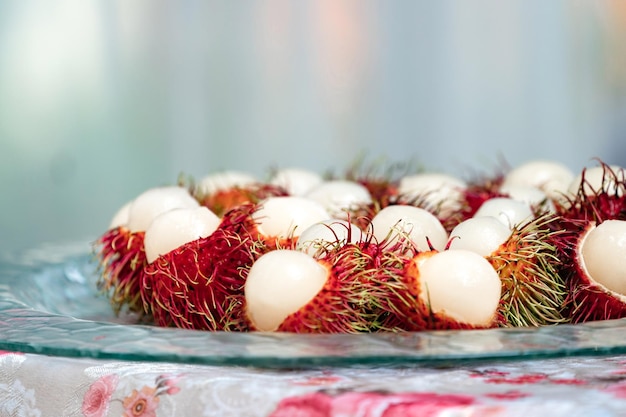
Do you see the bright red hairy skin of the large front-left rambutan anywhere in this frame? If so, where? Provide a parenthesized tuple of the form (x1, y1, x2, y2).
(141, 204, 270, 331)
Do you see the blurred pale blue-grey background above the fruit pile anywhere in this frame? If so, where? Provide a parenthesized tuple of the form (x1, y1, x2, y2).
(0, 0, 626, 250)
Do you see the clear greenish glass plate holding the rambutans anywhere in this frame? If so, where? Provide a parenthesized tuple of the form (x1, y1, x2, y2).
(0, 243, 626, 368)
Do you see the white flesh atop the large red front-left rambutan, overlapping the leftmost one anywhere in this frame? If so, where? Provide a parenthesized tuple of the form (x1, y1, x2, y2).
(143, 207, 220, 263)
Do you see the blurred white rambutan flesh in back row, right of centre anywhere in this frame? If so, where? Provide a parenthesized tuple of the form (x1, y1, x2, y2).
(398, 172, 467, 215)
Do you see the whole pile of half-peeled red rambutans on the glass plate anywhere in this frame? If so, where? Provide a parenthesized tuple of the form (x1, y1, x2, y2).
(94, 160, 626, 333)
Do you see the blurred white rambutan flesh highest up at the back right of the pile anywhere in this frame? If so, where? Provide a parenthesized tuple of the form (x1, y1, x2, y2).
(502, 160, 574, 199)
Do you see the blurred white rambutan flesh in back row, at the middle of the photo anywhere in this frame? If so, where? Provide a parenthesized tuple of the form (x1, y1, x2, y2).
(306, 180, 372, 219)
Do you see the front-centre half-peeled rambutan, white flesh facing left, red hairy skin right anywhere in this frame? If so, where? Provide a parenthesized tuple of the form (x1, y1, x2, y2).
(245, 241, 404, 333)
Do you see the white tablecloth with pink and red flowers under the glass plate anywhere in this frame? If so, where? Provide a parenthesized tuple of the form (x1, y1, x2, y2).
(0, 352, 626, 417)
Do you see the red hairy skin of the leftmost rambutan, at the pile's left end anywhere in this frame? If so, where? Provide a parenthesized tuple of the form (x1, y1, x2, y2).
(94, 226, 150, 318)
